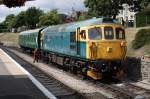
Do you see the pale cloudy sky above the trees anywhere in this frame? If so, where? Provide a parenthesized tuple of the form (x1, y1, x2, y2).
(0, 0, 85, 22)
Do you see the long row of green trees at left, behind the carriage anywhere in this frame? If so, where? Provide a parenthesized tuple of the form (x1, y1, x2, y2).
(0, 7, 64, 32)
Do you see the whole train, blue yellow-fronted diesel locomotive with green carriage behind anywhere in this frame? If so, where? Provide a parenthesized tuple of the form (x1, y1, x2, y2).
(19, 18, 127, 79)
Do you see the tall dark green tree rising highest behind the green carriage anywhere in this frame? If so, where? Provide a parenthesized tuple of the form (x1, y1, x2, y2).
(25, 7, 43, 28)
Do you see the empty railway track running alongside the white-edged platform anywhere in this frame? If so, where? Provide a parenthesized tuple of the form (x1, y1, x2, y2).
(2, 47, 84, 99)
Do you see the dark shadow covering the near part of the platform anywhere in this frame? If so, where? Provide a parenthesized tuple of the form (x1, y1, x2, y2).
(0, 75, 47, 99)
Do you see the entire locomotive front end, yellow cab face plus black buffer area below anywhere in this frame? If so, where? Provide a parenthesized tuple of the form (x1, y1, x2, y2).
(79, 23, 127, 79)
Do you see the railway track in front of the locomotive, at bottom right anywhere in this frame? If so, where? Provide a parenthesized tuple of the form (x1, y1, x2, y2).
(89, 81, 150, 99)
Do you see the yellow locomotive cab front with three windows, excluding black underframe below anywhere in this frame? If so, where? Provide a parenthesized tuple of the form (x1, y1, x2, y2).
(87, 24, 126, 60)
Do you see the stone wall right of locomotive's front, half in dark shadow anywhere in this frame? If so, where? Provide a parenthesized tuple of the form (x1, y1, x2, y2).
(124, 56, 150, 81)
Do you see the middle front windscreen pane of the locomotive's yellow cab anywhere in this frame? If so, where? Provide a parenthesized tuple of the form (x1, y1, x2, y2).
(104, 27, 114, 39)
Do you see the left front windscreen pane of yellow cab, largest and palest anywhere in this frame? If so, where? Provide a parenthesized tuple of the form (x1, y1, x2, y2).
(88, 27, 102, 40)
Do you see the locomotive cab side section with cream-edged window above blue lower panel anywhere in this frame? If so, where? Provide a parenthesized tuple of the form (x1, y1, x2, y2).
(76, 28, 87, 57)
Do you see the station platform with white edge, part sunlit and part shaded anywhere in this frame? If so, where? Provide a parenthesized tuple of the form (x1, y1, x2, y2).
(0, 49, 51, 99)
